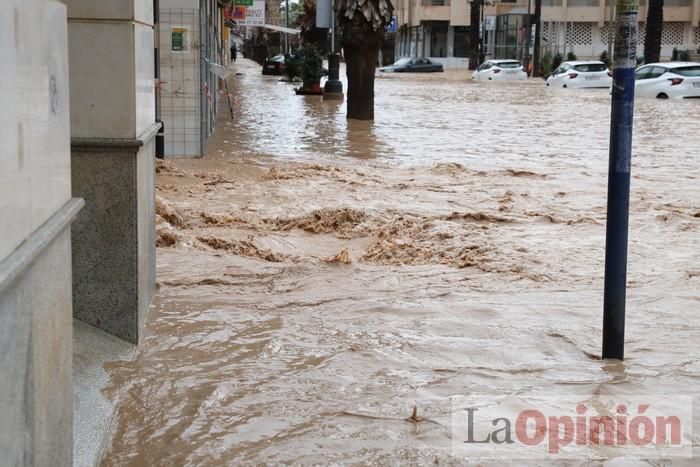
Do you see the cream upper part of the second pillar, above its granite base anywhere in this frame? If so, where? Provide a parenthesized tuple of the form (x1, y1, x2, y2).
(62, 0, 155, 138)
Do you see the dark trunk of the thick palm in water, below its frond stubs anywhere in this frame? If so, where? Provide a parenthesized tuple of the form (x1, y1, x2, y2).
(341, 24, 384, 120)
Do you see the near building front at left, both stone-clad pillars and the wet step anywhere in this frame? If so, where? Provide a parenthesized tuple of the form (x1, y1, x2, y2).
(0, 0, 160, 466)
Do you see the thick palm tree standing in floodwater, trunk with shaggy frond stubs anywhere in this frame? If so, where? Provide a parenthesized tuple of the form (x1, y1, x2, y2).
(335, 0, 394, 120)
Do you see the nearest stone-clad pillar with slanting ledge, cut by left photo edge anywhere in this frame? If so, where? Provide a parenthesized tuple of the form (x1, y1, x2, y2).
(0, 0, 82, 466)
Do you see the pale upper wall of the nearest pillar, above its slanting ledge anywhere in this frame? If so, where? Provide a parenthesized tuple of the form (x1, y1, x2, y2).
(0, 0, 71, 261)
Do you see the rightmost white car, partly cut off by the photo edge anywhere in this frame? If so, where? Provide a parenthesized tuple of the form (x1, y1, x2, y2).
(634, 62, 700, 99)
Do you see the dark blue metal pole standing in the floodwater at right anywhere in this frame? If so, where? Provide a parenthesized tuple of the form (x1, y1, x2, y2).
(603, 0, 639, 360)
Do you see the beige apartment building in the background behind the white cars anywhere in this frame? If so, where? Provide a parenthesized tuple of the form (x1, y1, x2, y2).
(396, 0, 700, 68)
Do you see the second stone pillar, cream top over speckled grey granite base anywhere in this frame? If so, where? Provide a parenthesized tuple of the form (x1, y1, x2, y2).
(62, 0, 159, 343)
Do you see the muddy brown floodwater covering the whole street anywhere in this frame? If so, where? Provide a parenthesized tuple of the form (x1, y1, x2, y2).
(103, 62, 700, 466)
